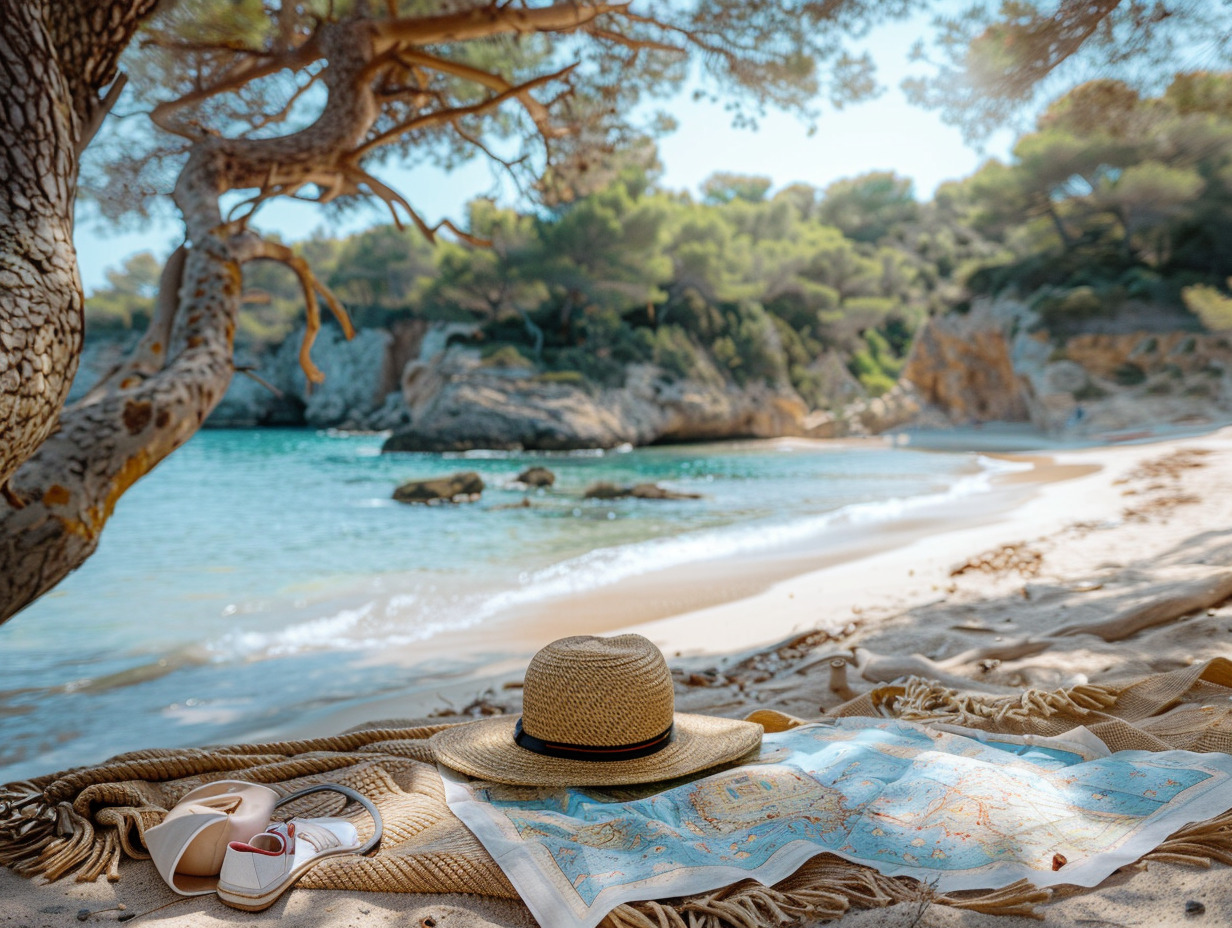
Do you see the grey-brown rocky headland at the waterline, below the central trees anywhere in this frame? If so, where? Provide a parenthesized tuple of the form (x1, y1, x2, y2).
(384, 348, 807, 451)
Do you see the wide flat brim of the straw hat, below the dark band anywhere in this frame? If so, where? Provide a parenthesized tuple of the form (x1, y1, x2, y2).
(430, 712, 761, 786)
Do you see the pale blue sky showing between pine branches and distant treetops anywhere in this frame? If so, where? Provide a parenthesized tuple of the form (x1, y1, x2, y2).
(75, 18, 1011, 293)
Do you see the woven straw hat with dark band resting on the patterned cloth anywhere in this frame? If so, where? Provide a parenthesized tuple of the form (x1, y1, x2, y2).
(431, 635, 761, 786)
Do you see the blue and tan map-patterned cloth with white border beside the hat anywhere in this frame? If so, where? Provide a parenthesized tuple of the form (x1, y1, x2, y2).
(442, 717, 1232, 928)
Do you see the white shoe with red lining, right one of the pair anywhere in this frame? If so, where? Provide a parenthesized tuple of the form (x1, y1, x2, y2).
(218, 818, 360, 912)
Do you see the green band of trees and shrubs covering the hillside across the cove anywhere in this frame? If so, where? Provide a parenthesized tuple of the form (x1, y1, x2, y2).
(86, 73, 1232, 408)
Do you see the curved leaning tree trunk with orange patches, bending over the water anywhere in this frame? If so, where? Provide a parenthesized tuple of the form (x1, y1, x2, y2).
(0, 21, 378, 621)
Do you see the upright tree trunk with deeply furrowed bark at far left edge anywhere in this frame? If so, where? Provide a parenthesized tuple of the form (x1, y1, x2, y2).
(0, 0, 154, 488)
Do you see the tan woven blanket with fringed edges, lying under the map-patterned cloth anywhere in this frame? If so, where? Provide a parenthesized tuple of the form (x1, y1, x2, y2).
(0, 658, 1232, 928)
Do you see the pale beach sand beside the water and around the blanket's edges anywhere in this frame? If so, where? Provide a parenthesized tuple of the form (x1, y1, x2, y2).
(0, 429, 1232, 928)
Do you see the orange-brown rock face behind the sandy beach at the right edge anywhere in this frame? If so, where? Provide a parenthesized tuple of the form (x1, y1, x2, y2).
(904, 301, 1232, 436)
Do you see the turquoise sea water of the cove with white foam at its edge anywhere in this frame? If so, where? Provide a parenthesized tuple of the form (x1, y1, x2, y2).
(0, 430, 1010, 783)
